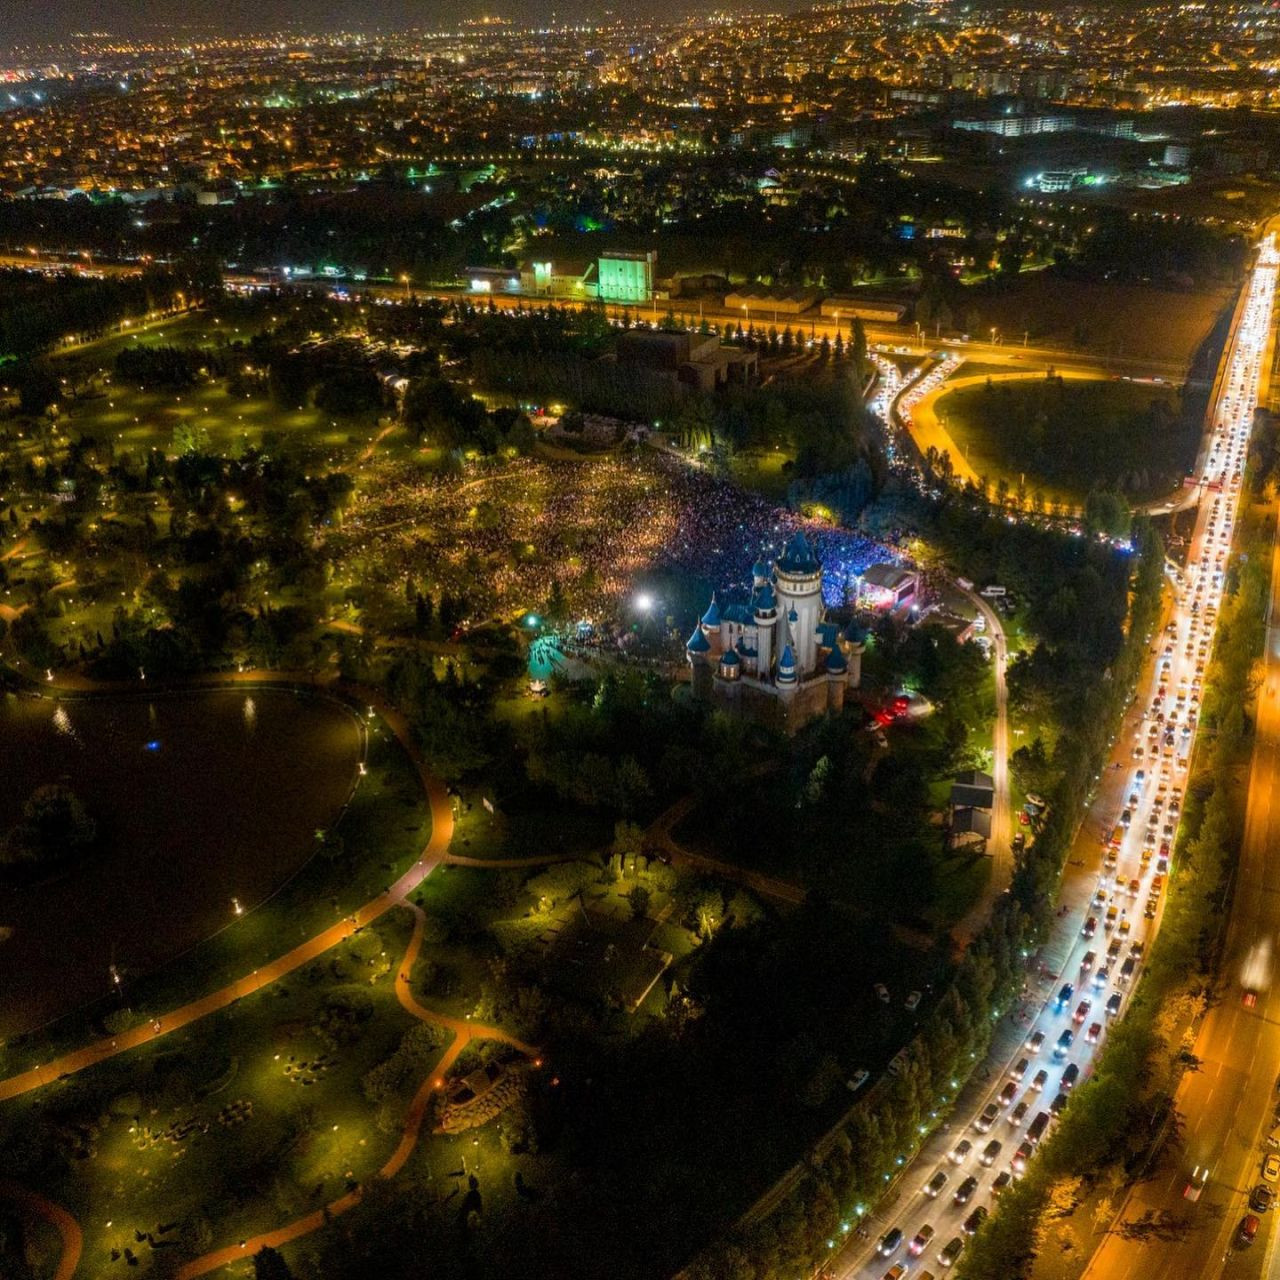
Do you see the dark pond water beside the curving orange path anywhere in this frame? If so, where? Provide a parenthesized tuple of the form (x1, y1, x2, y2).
(0, 689, 361, 1038)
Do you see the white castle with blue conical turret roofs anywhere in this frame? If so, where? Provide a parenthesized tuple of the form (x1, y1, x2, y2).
(685, 531, 863, 728)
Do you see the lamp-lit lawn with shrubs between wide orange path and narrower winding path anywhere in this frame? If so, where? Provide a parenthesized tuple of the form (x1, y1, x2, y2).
(17, 913, 448, 1265)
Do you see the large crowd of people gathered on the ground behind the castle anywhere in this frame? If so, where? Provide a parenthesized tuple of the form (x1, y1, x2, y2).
(334, 452, 891, 623)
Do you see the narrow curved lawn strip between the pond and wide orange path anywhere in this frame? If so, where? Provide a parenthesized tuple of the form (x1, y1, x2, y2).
(5, 716, 431, 1074)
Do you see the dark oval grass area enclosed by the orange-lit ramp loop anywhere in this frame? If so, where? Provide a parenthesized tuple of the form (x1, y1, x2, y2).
(934, 378, 1201, 506)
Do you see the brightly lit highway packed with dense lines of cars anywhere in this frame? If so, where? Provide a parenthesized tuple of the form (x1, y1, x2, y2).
(835, 236, 1280, 1280)
